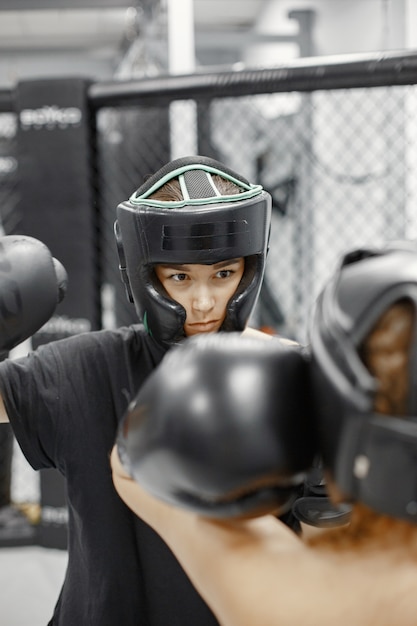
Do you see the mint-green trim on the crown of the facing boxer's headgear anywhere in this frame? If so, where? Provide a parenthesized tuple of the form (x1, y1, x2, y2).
(129, 163, 263, 208)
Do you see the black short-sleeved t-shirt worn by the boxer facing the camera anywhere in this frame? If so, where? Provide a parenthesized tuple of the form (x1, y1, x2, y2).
(0, 325, 218, 626)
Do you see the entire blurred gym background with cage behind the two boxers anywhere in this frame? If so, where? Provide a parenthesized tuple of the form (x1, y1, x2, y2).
(0, 0, 417, 626)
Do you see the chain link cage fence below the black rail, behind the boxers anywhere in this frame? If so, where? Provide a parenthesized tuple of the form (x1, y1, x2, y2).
(94, 56, 417, 343)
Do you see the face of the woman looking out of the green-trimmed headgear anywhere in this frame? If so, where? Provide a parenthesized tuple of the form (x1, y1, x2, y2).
(155, 257, 245, 337)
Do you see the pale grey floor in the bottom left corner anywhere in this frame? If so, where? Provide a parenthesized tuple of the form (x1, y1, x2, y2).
(0, 546, 67, 626)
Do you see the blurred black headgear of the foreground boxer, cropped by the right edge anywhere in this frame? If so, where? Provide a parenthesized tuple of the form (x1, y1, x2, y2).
(310, 243, 417, 523)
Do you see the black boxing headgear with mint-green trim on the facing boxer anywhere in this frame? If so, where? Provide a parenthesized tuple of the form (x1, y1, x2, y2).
(115, 156, 272, 346)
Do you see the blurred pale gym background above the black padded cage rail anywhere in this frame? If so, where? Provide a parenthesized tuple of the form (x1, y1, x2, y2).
(0, 0, 417, 85)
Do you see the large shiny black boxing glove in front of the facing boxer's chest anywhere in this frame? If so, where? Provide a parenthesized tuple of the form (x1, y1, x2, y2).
(117, 333, 316, 518)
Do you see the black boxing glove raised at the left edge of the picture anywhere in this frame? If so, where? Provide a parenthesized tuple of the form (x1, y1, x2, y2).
(0, 235, 67, 351)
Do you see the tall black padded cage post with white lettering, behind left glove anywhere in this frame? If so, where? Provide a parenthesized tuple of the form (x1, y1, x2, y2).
(16, 78, 100, 548)
